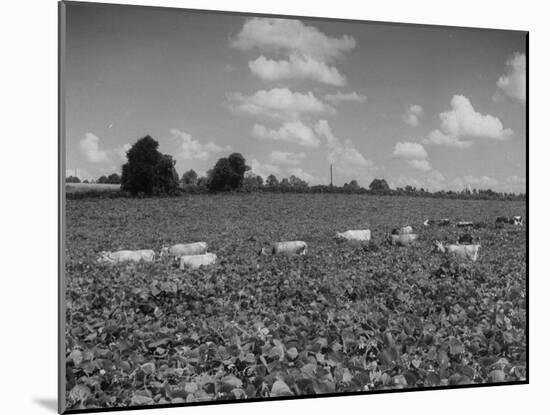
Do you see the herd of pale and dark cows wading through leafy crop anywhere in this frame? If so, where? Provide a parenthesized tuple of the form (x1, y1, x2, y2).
(98, 216, 524, 270)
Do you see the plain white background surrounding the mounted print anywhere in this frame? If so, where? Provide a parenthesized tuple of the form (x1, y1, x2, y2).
(0, 0, 550, 415)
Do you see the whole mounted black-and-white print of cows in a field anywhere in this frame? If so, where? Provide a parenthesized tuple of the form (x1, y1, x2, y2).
(58, 1, 529, 413)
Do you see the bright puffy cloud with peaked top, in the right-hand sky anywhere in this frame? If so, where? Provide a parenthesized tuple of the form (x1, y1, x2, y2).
(423, 95, 513, 148)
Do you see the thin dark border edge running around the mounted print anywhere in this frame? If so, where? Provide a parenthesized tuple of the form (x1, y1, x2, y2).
(57, 0, 530, 414)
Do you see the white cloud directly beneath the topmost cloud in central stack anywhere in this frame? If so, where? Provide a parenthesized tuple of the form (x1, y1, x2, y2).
(252, 55, 346, 86)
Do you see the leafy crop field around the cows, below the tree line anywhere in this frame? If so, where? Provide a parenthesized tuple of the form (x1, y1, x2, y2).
(66, 194, 527, 409)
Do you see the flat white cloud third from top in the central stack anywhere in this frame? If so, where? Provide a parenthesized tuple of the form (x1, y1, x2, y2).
(228, 88, 333, 120)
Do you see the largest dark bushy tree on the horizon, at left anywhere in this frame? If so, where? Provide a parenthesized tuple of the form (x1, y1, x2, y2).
(121, 136, 178, 196)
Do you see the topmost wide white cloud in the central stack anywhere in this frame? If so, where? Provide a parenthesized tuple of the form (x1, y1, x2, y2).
(231, 17, 355, 62)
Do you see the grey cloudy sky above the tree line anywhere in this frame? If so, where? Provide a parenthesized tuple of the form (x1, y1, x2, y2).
(65, 3, 527, 193)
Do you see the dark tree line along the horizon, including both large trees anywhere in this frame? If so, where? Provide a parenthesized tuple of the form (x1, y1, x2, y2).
(66, 135, 525, 200)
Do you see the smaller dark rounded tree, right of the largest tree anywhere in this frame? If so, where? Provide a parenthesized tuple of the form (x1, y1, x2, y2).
(208, 153, 250, 192)
